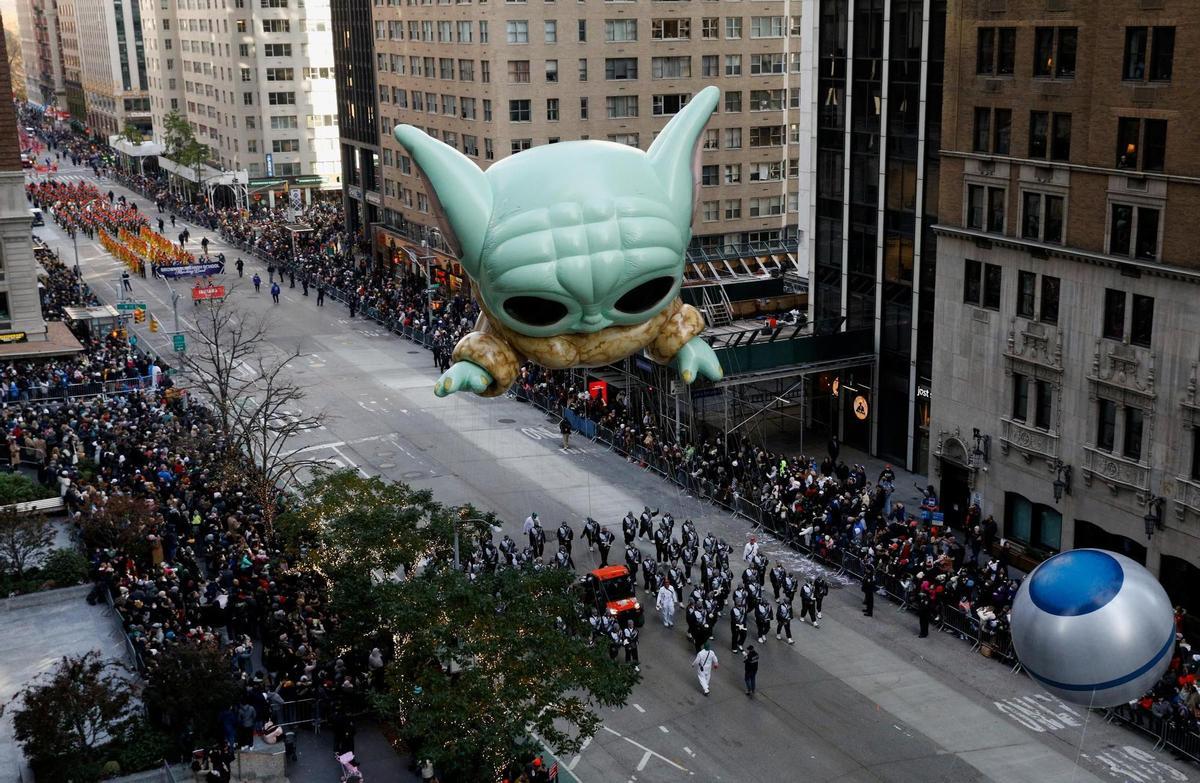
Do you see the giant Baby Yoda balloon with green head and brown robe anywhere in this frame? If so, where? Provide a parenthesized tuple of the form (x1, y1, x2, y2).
(396, 86, 721, 396)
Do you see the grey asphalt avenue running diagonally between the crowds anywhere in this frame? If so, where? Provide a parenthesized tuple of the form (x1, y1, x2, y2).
(28, 162, 1198, 783)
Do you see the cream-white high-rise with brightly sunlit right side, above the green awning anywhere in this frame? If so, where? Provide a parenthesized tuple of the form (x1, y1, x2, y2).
(144, 0, 341, 201)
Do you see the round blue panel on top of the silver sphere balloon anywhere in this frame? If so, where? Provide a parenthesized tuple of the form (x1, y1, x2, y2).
(1030, 549, 1124, 617)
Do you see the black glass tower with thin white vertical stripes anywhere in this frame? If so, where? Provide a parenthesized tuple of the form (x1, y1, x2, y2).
(808, 0, 947, 472)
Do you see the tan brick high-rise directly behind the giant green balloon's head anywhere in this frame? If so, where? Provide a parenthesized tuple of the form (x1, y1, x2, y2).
(335, 0, 815, 263)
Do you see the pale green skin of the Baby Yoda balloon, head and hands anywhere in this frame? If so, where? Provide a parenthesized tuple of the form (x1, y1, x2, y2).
(395, 86, 724, 396)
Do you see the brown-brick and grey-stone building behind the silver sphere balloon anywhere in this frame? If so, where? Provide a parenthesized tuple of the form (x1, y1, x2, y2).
(931, 0, 1200, 595)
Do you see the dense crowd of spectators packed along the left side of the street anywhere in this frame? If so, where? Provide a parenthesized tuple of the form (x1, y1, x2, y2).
(12, 192, 370, 763)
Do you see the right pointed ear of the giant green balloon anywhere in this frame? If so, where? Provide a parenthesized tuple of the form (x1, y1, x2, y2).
(646, 86, 721, 227)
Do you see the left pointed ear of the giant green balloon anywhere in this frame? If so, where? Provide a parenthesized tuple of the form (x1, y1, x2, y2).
(395, 125, 492, 275)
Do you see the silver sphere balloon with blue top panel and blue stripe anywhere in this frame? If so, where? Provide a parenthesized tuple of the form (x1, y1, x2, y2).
(1010, 549, 1175, 707)
